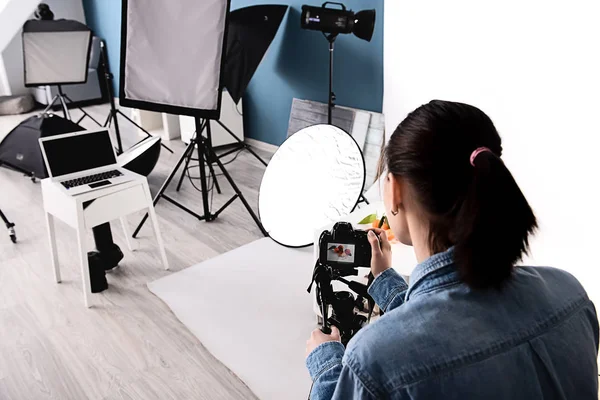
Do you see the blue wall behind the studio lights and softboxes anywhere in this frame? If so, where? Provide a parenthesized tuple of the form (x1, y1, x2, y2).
(83, 0, 383, 145)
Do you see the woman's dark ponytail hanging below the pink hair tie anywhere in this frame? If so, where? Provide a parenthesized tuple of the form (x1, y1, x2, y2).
(452, 151, 537, 288)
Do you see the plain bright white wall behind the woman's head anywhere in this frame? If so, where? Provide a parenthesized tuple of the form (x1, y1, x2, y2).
(383, 0, 600, 305)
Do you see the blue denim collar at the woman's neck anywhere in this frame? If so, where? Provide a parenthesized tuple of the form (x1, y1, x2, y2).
(404, 247, 460, 301)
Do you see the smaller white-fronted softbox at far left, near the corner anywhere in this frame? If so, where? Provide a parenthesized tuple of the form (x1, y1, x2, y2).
(23, 19, 92, 87)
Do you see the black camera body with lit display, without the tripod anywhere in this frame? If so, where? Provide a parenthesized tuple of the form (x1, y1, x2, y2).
(319, 222, 371, 270)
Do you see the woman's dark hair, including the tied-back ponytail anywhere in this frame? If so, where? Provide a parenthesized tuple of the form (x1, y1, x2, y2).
(384, 100, 537, 288)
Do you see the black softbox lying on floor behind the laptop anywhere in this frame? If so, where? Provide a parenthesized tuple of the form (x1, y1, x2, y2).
(0, 115, 84, 179)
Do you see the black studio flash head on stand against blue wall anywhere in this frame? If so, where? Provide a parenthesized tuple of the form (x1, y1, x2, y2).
(300, 1, 375, 42)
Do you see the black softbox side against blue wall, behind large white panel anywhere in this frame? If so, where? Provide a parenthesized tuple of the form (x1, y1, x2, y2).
(223, 5, 288, 104)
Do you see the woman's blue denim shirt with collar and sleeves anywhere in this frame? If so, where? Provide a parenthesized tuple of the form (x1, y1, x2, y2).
(306, 249, 598, 400)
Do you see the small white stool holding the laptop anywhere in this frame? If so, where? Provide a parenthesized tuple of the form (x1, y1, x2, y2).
(42, 175, 169, 307)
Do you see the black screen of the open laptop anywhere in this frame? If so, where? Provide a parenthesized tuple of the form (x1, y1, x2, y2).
(42, 131, 117, 177)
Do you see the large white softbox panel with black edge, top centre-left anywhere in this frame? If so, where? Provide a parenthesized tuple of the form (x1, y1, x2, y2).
(120, 0, 229, 119)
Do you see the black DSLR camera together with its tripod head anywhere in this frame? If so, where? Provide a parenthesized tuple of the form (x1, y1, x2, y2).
(308, 222, 374, 345)
